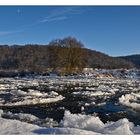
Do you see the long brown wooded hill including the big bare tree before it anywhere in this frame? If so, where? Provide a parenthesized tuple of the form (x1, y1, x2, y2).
(0, 38, 134, 72)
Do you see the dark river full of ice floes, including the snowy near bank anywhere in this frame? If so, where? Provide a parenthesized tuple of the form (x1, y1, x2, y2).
(0, 70, 140, 134)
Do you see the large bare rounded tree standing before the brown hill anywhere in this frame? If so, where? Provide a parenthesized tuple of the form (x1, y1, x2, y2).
(50, 37, 86, 72)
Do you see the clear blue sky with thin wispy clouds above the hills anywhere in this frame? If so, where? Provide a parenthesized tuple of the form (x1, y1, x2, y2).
(0, 6, 140, 56)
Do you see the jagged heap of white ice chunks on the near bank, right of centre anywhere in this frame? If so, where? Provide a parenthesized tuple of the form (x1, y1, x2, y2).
(61, 111, 137, 134)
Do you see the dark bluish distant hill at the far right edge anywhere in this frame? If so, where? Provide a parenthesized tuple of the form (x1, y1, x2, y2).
(119, 54, 140, 69)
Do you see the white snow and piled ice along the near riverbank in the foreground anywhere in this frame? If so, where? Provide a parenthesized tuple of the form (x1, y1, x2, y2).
(0, 111, 140, 135)
